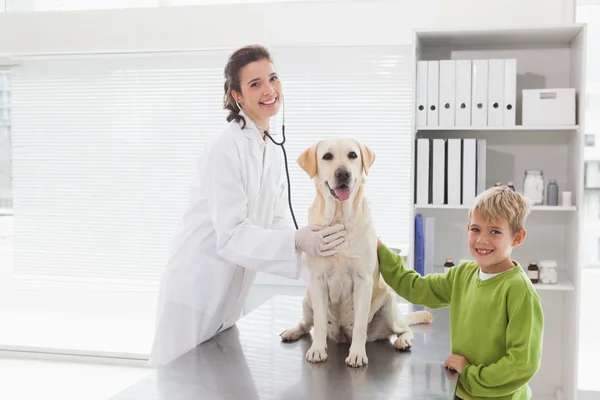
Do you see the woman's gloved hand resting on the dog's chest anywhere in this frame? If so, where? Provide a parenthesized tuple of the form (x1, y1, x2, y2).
(296, 224, 346, 257)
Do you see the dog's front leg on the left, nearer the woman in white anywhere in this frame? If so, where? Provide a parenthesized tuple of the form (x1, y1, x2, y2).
(306, 276, 329, 362)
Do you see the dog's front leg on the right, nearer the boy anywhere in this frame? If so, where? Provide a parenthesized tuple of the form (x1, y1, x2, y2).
(346, 274, 373, 367)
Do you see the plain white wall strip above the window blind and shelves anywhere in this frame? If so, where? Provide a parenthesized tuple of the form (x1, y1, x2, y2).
(0, 0, 575, 54)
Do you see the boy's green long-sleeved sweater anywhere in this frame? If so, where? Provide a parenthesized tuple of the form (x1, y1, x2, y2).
(377, 245, 544, 400)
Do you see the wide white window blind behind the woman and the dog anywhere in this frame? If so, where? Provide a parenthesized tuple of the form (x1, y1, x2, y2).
(12, 46, 412, 290)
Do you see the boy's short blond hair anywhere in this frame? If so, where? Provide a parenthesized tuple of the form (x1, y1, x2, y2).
(469, 185, 531, 235)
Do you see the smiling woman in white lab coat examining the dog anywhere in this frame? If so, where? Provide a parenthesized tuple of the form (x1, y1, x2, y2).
(149, 46, 346, 367)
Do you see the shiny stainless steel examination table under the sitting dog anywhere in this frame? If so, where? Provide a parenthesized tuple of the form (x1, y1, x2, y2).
(113, 296, 458, 400)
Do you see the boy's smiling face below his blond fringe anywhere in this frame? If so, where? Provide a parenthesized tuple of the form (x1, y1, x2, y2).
(468, 210, 526, 273)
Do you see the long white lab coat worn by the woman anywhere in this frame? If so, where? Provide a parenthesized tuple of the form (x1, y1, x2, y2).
(149, 114, 301, 367)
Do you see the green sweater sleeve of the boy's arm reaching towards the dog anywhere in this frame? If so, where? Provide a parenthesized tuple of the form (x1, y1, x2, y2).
(377, 245, 455, 308)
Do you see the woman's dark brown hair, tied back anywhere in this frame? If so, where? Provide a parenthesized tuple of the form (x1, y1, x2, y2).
(223, 45, 273, 128)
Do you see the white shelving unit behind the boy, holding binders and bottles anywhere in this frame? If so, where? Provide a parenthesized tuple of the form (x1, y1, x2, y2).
(409, 24, 586, 399)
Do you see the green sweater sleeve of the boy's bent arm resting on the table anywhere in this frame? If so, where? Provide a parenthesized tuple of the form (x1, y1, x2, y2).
(460, 290, 544, 397)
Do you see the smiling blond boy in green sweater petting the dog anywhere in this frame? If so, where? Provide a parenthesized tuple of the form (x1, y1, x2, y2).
(377, 186, 544, 400)
